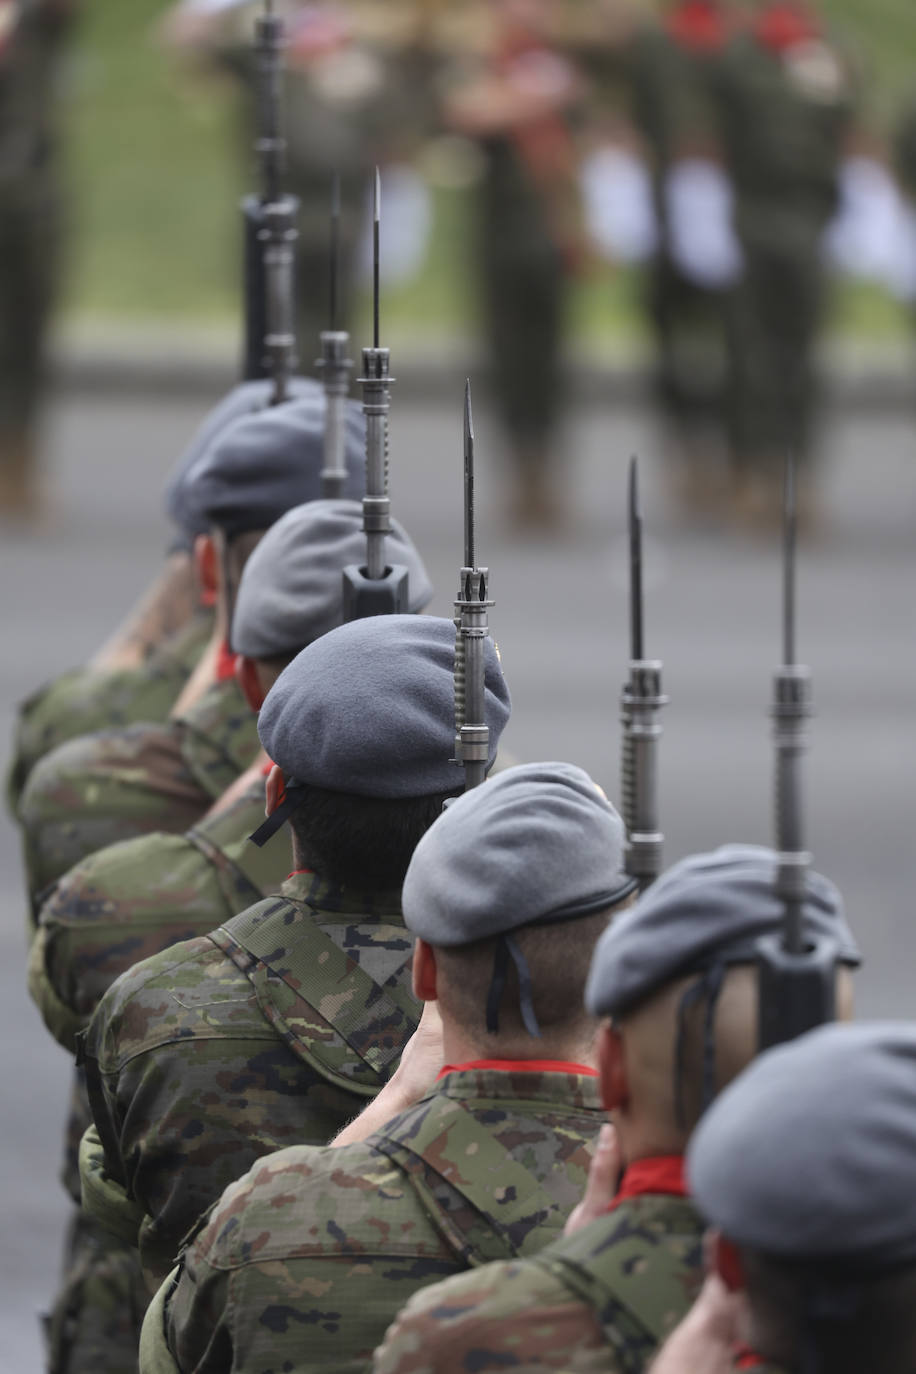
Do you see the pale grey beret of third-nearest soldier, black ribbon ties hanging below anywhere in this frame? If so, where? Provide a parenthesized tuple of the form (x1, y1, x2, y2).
(401, 763, 633, 945)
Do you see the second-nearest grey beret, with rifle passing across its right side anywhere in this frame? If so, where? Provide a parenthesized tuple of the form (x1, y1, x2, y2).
(585, 845, 860, 1015)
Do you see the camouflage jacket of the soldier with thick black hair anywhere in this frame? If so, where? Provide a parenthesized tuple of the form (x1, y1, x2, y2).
(82, 874, 419, 1282)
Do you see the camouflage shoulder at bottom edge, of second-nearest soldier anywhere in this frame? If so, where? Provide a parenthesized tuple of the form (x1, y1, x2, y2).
(372, 1261, 621, 1374)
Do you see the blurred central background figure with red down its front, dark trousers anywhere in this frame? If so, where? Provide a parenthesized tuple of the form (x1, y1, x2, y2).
(444, 0, 585, 532)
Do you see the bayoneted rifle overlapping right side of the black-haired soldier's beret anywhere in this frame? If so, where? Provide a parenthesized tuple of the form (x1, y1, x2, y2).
(455, 379, 493, 791)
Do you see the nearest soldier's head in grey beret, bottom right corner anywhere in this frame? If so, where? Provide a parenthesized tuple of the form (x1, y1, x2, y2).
(688, 1022, 916, 1374)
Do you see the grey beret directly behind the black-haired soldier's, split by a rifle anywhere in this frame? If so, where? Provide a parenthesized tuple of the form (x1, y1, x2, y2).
(232, 502, 433, 658)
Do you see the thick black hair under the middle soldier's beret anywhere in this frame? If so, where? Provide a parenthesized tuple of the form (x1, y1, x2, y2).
(290, 783, 463, 890)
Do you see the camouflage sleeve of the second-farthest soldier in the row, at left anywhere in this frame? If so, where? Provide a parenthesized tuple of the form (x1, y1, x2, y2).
(19, 677, 260, 911)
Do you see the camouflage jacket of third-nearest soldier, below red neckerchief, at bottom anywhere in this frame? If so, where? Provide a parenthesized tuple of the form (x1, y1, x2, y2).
(140, 1068, 603, 1374)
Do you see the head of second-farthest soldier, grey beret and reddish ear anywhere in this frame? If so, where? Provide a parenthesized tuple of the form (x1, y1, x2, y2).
(169, 382, 365, 636)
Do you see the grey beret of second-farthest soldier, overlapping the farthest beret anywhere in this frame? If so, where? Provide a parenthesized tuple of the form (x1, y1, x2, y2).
(170, 392, 365, 534)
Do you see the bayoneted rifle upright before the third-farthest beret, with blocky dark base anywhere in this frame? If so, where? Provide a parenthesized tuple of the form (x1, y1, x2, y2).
(343, 168, 409, 620)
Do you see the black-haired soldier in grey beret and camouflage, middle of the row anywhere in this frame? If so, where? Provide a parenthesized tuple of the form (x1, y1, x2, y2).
(75, 616, 508, 1302)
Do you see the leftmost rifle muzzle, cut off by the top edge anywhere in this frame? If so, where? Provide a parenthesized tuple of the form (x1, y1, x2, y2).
(242, 0, 299, 404)
